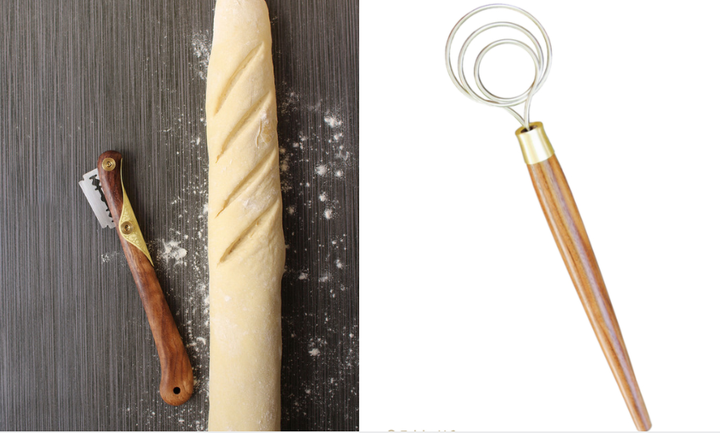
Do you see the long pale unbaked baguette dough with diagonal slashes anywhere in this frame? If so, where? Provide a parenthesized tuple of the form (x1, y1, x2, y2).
(206, 0, 285, 430)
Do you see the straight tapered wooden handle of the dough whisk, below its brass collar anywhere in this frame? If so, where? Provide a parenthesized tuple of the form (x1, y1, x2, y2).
(528, 155, 652, 431)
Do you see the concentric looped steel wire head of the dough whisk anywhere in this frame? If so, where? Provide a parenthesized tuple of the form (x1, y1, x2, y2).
(445, 4, 552, 129)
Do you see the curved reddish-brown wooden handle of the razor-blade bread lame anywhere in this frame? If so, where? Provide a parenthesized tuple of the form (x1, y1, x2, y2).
(98, 150, 193, 406)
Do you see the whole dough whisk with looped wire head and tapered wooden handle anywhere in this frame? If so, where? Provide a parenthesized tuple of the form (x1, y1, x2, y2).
(445, 4, 652, 431)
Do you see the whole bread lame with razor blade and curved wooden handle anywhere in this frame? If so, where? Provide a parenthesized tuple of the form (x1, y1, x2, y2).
(80, 150, 193, 406)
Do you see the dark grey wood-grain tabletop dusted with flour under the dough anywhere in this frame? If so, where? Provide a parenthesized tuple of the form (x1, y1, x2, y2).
(0, 0, 359, 430)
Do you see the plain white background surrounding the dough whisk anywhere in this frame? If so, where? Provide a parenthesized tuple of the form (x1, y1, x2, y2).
(360, 0, 720, 431)
